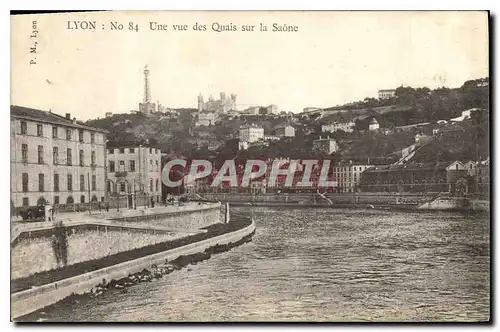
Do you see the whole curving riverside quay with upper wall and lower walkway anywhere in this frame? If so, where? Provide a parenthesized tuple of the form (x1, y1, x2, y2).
(11, 203, 255, 319)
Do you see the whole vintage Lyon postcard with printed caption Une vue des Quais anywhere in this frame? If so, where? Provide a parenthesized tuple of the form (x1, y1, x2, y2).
(10, 11, 491, 323)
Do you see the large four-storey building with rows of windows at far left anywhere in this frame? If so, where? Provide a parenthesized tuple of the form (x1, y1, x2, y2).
(10, 105, 106, 209)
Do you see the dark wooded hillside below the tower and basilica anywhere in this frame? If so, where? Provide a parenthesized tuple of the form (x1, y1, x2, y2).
(87, 79, 489, 163)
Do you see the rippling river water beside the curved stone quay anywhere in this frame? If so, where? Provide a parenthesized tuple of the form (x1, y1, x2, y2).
(31, 208, 490, 322)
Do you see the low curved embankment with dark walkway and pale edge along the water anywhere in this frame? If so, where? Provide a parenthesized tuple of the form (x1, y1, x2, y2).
(11, 216, 255, 319)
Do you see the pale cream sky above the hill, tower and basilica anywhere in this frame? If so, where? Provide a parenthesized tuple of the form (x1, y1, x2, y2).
(11, 11, 489, 120)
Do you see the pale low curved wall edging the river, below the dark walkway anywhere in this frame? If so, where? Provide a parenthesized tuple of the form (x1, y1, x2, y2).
(11, 217, 255, 319)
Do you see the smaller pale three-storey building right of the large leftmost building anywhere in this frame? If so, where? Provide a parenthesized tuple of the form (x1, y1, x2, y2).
(106, 143, 161, 208)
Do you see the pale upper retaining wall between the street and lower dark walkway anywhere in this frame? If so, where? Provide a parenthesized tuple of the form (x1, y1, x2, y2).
(11, 204, 223, 279)
